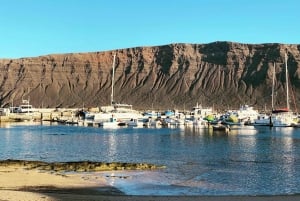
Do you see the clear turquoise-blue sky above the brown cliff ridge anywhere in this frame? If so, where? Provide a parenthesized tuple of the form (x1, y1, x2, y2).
(0, 0, 300, 58)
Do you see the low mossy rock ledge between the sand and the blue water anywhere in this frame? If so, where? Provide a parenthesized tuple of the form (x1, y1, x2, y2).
(0, 159, 164, 172)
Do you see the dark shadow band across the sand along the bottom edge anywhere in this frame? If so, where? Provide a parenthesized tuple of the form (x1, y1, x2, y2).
(18, 186, 300, 201)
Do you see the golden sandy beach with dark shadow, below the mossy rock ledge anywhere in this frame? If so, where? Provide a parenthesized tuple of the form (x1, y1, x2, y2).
(0, 166, 300, 201)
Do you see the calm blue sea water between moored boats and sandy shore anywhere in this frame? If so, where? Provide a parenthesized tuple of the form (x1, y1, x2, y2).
(0, 123, 300, 195)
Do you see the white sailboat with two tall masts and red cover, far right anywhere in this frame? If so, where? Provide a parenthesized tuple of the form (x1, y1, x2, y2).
(270, 53, 296, 127)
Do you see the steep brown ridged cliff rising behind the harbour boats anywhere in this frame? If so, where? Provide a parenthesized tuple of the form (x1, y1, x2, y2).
(0, 42, 300, 109)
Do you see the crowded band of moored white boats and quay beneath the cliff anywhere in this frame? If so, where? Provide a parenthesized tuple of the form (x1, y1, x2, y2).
(0, 104, 299, 128)
